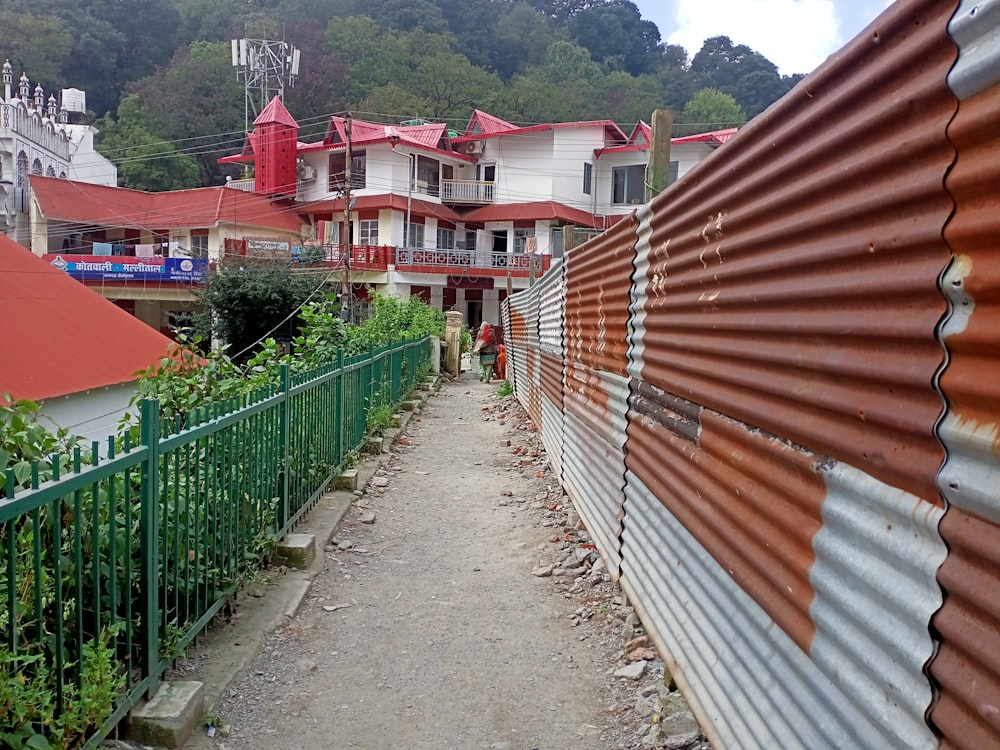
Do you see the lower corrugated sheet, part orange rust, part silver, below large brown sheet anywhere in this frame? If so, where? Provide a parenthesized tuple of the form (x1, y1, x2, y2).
(622, 406, 946, 750)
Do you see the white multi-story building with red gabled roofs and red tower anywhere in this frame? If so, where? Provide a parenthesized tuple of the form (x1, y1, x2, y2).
(222, 98, 735, 324)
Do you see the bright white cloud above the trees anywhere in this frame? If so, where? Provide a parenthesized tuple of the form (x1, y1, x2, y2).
(667, 0, 844, 75)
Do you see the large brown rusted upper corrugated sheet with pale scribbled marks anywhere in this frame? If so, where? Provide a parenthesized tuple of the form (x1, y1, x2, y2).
(632, 1, 956, 508)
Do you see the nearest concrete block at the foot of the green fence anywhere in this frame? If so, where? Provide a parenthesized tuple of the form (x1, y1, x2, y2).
(128, 682, 205, 748)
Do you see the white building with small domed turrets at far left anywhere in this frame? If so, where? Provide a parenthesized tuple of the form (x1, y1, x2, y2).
(0, 61, 118, 245)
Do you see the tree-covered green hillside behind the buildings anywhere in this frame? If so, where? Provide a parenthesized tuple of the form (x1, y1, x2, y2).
(0, 0, 799, 190)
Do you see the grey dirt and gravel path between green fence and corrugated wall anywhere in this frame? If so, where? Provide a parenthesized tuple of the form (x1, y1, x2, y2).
(186, 373, 699, 750)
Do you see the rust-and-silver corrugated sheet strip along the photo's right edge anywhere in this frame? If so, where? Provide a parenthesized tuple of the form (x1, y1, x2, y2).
(929, 13, 1000, 750)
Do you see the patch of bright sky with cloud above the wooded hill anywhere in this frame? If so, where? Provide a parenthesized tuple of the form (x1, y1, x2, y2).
(633, 0, 890, 75)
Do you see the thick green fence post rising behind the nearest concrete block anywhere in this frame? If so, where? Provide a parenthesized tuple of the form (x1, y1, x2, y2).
(139, 398, 160, 698)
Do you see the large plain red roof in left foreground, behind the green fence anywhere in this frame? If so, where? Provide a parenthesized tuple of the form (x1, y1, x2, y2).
(0, 235, 170, 401)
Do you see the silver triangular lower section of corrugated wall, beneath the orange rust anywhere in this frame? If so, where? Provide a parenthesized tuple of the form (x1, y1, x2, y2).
(621, 472, 936, 750)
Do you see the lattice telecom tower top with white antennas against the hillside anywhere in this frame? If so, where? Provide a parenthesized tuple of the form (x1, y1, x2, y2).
(230, 23, 301, 133)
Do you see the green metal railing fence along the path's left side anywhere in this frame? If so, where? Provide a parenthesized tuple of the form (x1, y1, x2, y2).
(0, 338, 430, 745)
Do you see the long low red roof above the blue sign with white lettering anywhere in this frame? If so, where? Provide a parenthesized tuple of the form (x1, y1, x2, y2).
(30, 175, 299, 233)
